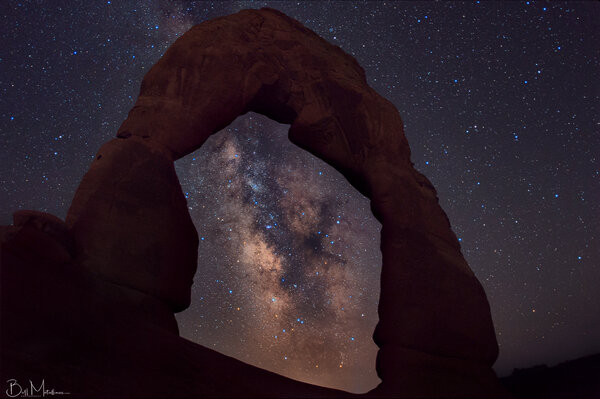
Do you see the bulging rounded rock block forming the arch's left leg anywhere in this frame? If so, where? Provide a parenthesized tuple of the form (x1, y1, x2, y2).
(66, 137, 198, 311)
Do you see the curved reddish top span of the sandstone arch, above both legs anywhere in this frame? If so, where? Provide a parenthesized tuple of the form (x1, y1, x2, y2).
(117, 9, 410, 203)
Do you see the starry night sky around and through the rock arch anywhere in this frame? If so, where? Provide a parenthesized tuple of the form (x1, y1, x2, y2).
(0, 0, 600, 391)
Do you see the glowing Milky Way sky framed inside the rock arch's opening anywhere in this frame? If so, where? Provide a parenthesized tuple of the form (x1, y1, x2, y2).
(177, 114, 381, 390)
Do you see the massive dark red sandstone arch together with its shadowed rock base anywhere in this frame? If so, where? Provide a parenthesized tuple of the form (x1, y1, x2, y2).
(1, 9, 505, 397)
